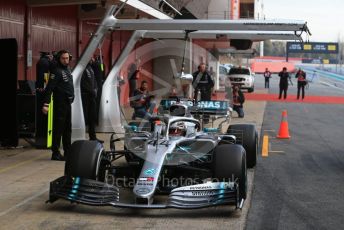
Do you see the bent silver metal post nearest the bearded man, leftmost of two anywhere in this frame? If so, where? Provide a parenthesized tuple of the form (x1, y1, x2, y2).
(72, 6, 117, 141)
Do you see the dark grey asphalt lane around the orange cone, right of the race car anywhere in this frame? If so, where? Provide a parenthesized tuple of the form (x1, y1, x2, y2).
(246, 73, 344, 230)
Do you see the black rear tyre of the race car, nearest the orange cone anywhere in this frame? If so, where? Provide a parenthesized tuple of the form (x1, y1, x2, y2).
(227, 124, 258, 168)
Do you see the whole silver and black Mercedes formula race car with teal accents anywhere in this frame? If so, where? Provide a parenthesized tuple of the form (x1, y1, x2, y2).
(49, 100, 258, 209)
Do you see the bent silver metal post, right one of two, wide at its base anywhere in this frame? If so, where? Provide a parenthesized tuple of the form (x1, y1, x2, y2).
(97, 30, 145, 133)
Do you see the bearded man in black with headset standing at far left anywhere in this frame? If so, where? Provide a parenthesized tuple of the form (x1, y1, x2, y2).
(42, 50, 74, 160)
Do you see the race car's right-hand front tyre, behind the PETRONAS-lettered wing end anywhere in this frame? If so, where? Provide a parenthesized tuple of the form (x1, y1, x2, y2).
(213, 144, 247, 200)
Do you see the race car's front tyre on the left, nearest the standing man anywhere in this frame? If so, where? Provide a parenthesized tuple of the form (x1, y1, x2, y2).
(65, 140, 109, 181)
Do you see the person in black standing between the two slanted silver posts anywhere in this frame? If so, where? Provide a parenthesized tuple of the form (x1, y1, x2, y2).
(80, 59, 104, 143)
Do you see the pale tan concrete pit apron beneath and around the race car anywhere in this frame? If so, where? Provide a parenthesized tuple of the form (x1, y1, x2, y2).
(0, 81, 266, 229)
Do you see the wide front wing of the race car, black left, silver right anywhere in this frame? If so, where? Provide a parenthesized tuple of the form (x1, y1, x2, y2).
(47, 176, 243, 209)
